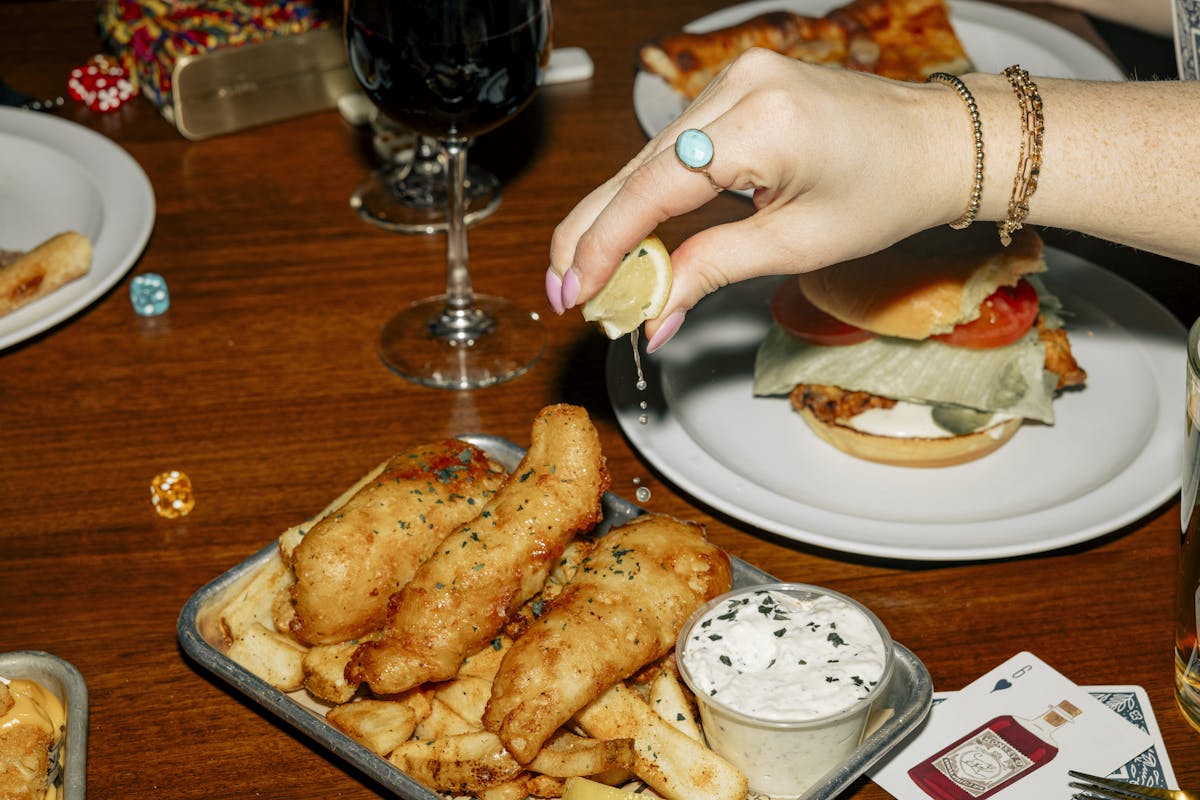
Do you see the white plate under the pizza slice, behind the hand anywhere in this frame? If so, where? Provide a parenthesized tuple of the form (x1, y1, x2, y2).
(634, 0, 1124, 137)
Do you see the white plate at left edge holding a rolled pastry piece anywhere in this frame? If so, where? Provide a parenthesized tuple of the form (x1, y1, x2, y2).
(0, 108, 155, 350)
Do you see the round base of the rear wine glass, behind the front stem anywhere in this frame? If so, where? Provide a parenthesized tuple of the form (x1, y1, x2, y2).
(350, 164, 500, 234)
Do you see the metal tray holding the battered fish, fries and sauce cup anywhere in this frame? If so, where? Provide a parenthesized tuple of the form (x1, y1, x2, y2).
(178, 434, 934, 800)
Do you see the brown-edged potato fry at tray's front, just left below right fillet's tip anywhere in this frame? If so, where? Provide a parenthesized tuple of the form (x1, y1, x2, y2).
(388, 730, 522, 794)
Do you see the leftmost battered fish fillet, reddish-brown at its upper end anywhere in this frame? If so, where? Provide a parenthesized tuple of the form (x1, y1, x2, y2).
(290, 439, 504, 644)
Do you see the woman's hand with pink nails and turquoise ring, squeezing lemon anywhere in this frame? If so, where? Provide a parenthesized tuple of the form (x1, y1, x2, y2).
(546, 50, 973, 350)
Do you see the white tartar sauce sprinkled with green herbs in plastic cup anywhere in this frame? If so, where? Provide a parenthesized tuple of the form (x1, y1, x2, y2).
(683, 590, 886, 722)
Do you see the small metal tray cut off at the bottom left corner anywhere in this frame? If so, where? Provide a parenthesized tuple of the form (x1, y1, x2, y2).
(0, 650, 88, 800)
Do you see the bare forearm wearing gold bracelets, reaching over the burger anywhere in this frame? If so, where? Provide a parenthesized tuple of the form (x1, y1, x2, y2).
(964, 74, 1200, 263)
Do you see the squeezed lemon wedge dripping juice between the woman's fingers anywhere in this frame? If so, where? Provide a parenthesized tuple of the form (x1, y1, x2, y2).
(582, 235, 672, 339)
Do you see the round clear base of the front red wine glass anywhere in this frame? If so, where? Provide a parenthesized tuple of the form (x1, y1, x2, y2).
(379, 294, 546, 389)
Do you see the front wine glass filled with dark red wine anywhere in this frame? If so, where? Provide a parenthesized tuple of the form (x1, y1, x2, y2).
(346, 0, 551, 389)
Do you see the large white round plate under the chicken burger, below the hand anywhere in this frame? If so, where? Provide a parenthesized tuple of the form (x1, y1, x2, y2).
(607, 248, 1187, 560)
